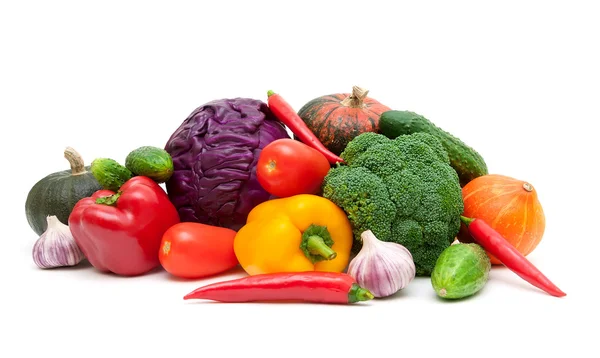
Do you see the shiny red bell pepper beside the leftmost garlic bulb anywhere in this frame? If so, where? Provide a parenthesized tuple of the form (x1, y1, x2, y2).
(69, 176, 180, 276)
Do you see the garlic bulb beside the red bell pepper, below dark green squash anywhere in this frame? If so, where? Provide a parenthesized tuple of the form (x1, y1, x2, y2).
(33, 216, 85, 269)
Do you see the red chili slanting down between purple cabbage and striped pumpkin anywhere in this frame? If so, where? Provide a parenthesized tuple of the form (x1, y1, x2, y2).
(267, 91, 344, 164)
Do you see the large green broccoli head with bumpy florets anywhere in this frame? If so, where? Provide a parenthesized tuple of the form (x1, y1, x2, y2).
(323, 132, 464, 276)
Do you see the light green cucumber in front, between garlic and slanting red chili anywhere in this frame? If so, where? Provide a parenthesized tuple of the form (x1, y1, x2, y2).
(431, 243, 492, 299)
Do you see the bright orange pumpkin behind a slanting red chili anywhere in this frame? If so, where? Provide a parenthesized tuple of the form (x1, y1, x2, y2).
(458, 174, 546, 265)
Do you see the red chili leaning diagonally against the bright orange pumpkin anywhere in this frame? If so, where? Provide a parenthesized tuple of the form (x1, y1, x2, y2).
(460, 216, 567, 297)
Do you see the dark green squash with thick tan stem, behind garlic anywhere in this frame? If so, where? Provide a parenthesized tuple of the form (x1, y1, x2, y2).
(25, 147, 102, 235)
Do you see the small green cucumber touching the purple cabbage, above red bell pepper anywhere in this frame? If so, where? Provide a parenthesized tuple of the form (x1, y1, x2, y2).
(125, 146, 173, 183)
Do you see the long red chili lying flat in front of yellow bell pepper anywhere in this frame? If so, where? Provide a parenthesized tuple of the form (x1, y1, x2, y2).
(183, 271, 373, 304)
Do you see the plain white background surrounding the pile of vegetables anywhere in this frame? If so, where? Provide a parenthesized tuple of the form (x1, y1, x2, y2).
(0, 0, 600, 357)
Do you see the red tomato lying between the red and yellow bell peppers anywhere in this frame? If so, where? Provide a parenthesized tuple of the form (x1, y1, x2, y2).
(158, 222, 238, 278)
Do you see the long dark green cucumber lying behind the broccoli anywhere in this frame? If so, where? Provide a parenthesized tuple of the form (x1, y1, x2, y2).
(379, 110, 488, 187)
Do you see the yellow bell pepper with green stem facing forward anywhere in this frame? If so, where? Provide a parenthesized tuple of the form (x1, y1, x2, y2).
(234, 194, 354, 275)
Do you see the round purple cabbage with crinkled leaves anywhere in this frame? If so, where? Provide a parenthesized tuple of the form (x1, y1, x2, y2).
(165, 98, 289, 231)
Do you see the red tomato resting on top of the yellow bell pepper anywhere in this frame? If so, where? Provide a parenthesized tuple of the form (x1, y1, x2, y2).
(256, 138, 331, 198)
